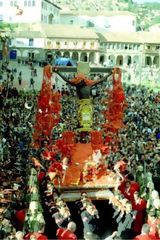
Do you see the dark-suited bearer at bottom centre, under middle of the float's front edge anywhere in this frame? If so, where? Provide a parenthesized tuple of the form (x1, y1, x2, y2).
(81, 203, 99, 240)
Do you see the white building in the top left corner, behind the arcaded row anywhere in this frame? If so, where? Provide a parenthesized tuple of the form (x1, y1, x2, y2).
(0, 0, 60, 24)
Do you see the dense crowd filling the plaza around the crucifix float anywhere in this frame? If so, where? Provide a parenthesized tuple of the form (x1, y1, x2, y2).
(0, 58, 160, 240)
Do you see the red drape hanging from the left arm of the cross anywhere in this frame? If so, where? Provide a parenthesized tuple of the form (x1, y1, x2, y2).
(33, 65, 61, 146)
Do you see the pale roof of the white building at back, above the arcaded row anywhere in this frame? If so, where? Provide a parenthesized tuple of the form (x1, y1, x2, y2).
(60, 10, 136, 17)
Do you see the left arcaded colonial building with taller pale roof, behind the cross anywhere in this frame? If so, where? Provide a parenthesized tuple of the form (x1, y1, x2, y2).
(10, 24, 99, 63)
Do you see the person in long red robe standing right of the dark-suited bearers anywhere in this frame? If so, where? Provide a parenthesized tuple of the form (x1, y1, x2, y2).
(132, 192, 147, 234)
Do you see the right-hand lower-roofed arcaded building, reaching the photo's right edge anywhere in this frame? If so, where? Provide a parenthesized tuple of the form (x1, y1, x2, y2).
(100, 32, 160, 67)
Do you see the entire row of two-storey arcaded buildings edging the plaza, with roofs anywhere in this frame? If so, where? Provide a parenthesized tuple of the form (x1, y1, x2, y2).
(7, 24, 160, 67)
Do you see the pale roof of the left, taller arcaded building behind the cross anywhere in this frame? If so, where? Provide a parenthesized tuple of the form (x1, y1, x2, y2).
(14, 23, 98, 40)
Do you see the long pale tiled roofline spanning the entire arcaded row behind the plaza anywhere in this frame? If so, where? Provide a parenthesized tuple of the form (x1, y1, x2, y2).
(11, 23, 160, 44)
